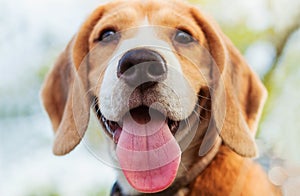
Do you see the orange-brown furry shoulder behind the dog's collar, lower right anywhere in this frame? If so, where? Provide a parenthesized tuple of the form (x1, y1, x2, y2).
(189, 146, 281, 196)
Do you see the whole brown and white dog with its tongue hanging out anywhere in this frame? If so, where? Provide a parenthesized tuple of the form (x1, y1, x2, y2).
(42, 0, 280, 195)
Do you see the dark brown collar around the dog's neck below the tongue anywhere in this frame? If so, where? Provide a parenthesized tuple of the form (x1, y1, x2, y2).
(110, 135, 222, 196)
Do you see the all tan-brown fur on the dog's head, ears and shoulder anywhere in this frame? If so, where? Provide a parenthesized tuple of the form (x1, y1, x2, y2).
(42, 0, 279, 195)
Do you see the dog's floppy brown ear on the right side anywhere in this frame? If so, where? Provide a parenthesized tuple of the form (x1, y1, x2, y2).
(191, 7, 267, 157)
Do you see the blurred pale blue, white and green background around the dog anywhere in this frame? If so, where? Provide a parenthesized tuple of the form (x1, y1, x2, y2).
(0, 0, 300, 196)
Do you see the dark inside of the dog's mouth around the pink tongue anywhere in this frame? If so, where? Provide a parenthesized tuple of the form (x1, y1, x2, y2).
(97, 106, 180, 144)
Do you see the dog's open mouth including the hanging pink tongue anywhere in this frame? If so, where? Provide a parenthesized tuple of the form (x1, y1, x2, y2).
(95, 103, 181, 193)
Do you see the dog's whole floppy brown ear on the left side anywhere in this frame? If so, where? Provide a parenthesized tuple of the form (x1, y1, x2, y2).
(41, 7, 103, 155)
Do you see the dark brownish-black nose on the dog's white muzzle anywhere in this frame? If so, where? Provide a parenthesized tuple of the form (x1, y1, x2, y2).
(117, 49, 167, 87)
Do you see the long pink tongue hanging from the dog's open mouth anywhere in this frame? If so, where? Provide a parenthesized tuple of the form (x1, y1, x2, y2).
(116, 110, 181, 193)
